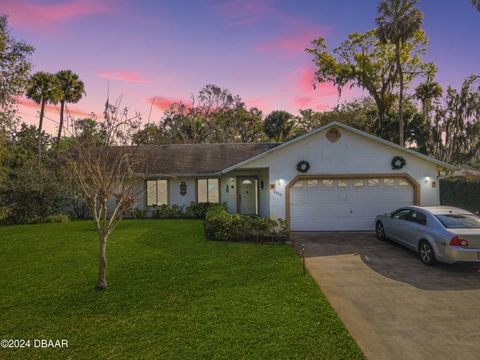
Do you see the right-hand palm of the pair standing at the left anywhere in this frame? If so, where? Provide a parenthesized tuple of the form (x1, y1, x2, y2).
(55, 70, 85, 151)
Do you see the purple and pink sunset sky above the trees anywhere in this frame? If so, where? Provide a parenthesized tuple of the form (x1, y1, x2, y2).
(4, 0, 480, 131)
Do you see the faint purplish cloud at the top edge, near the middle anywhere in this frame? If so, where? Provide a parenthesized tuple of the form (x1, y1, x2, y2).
(210, 0, 273, 25)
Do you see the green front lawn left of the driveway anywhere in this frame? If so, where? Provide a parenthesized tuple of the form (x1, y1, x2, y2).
(0, 220, 363, 359)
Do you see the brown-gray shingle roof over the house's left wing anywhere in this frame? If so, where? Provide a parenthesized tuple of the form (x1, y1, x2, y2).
(124, 143, 279, 176)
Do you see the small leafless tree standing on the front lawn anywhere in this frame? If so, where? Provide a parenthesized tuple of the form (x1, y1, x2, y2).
(66, 104, 147, 289)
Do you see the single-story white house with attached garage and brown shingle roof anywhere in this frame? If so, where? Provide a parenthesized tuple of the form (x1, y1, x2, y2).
(129, 122, 455, 231)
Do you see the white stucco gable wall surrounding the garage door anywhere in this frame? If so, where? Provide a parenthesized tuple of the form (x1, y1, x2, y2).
(238, 128, 439, 219)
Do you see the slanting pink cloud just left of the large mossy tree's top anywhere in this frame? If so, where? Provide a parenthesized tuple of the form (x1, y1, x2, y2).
(255, 27, 326, 57)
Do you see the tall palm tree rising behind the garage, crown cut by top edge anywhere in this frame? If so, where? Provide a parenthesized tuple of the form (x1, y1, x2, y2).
(375, 0, 423, 146)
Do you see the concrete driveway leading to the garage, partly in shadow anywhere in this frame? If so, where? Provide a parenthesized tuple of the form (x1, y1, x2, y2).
(292, 233, 480, 360)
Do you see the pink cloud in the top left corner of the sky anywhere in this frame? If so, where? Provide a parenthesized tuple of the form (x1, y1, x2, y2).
(2, 0, 114, 30)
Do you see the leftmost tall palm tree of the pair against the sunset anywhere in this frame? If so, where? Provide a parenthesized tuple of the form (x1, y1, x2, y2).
(26, 71, 60, 159)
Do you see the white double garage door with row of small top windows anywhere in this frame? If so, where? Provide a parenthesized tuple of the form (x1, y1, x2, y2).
(290, 177, 414, 231)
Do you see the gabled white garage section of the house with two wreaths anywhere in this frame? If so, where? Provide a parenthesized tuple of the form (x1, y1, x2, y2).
(225, 122, 455, 231)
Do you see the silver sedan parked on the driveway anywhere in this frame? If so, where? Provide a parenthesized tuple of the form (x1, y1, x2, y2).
(375, 206, 480, 265)
